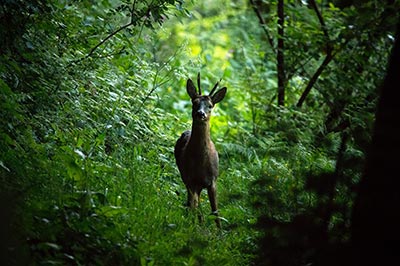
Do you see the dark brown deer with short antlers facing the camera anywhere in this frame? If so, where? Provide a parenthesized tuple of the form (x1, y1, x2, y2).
(174, 73, 227, 228)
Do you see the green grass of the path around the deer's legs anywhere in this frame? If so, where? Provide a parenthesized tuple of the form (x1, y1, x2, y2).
(112, 142, 255, 265)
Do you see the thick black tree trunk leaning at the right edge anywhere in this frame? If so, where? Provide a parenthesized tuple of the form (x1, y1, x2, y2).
(351, 23, 400, 265)
